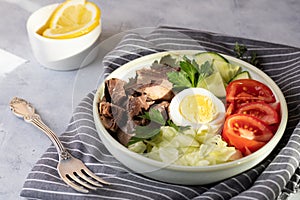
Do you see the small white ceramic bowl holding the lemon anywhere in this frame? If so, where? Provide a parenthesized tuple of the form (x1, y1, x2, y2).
(26, 4, 101, 70)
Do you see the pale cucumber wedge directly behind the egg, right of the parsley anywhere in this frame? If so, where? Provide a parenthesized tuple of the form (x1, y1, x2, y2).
(204, 72, 226, 98)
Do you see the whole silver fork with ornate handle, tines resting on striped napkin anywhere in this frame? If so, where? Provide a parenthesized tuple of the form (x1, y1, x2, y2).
(10, 97, 110, 193)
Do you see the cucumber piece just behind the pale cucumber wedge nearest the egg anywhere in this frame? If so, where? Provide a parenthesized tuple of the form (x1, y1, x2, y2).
(213, 60, 241, 83)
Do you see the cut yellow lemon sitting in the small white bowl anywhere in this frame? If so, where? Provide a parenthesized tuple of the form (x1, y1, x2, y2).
(43, 0, 101, 39)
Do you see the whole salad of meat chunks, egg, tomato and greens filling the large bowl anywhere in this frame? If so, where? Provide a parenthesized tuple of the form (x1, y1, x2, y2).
(99, 52, 280, 166)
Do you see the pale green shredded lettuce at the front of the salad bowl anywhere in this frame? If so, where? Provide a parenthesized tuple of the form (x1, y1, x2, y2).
(128, 126, 242, 166)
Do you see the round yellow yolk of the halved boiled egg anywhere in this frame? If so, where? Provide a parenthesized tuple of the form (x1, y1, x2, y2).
(179, 94, 216, 123)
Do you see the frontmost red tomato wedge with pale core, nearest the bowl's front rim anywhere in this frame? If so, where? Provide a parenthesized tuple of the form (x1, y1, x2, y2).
(222, 114, 273, 155)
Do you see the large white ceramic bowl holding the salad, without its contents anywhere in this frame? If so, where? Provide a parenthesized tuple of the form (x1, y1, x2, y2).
(93, 51, 287, 185)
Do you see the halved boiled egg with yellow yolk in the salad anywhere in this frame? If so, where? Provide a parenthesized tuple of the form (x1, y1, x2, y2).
(169, 88, 225, 133)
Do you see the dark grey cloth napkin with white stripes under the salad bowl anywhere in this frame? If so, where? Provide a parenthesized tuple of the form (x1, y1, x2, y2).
(21, 27, 300, 200)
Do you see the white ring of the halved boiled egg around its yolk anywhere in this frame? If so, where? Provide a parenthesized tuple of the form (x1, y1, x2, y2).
(169, 88, 225, 133)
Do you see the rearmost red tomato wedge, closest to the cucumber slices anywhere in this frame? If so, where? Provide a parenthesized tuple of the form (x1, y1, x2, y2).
(226, 79, 276, 103)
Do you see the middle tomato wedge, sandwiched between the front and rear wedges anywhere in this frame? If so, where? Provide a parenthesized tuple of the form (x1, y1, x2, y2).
(235, 102, 279, 125)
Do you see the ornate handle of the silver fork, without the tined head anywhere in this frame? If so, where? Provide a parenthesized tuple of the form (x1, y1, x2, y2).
(10, 97, 71, 160)
